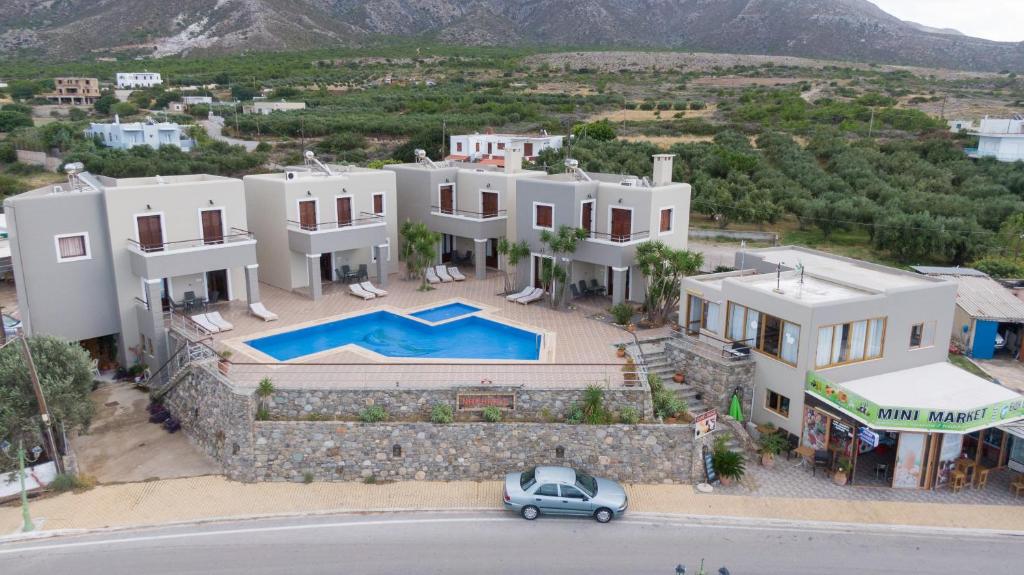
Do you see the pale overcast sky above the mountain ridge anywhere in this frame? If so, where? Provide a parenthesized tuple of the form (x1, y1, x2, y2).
(870, 0, 1024, 42)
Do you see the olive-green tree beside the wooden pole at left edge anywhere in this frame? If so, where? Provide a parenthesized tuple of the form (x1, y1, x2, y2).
(0, 336, 94, 456)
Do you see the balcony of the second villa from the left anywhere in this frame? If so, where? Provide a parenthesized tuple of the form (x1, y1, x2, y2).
(288, 213, 387, 254)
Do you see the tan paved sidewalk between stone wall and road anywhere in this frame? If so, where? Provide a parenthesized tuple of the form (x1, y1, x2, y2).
(0, 476, 1024, 534)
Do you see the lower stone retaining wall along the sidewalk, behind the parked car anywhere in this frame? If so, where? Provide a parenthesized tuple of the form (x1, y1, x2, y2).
(254, 422, 694, 483)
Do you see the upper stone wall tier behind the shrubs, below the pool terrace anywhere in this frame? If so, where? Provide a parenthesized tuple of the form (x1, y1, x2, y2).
(268, 385, 653, 422)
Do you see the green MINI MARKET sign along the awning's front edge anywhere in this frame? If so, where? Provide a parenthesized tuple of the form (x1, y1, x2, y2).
(805, 371, 1024, 433)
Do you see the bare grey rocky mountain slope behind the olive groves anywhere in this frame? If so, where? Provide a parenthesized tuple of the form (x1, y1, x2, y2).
(0, 0, 1024, 71)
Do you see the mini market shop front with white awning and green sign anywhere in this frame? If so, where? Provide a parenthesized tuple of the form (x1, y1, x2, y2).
(801, 362, 1024, 489)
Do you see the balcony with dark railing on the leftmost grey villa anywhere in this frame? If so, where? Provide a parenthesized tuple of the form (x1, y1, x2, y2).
(128, 228, 256, 279)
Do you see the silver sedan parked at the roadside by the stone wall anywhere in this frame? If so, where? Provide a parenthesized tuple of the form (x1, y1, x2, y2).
(503, 467, 629, 523)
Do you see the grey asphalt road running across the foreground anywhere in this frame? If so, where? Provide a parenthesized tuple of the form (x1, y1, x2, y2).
(0, 512, 1024, 575)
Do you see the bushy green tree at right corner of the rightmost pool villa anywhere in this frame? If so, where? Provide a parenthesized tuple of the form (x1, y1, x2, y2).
(636, 241, 703, 325)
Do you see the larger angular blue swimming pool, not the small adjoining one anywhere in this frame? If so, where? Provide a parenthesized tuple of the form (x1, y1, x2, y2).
(246, 310, 542, 361)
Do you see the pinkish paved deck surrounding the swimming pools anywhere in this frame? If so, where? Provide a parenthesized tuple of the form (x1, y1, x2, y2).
(201, 271, 653, 389)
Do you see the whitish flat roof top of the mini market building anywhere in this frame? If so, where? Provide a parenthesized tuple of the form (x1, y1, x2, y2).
(746, 246, 944, 292)
